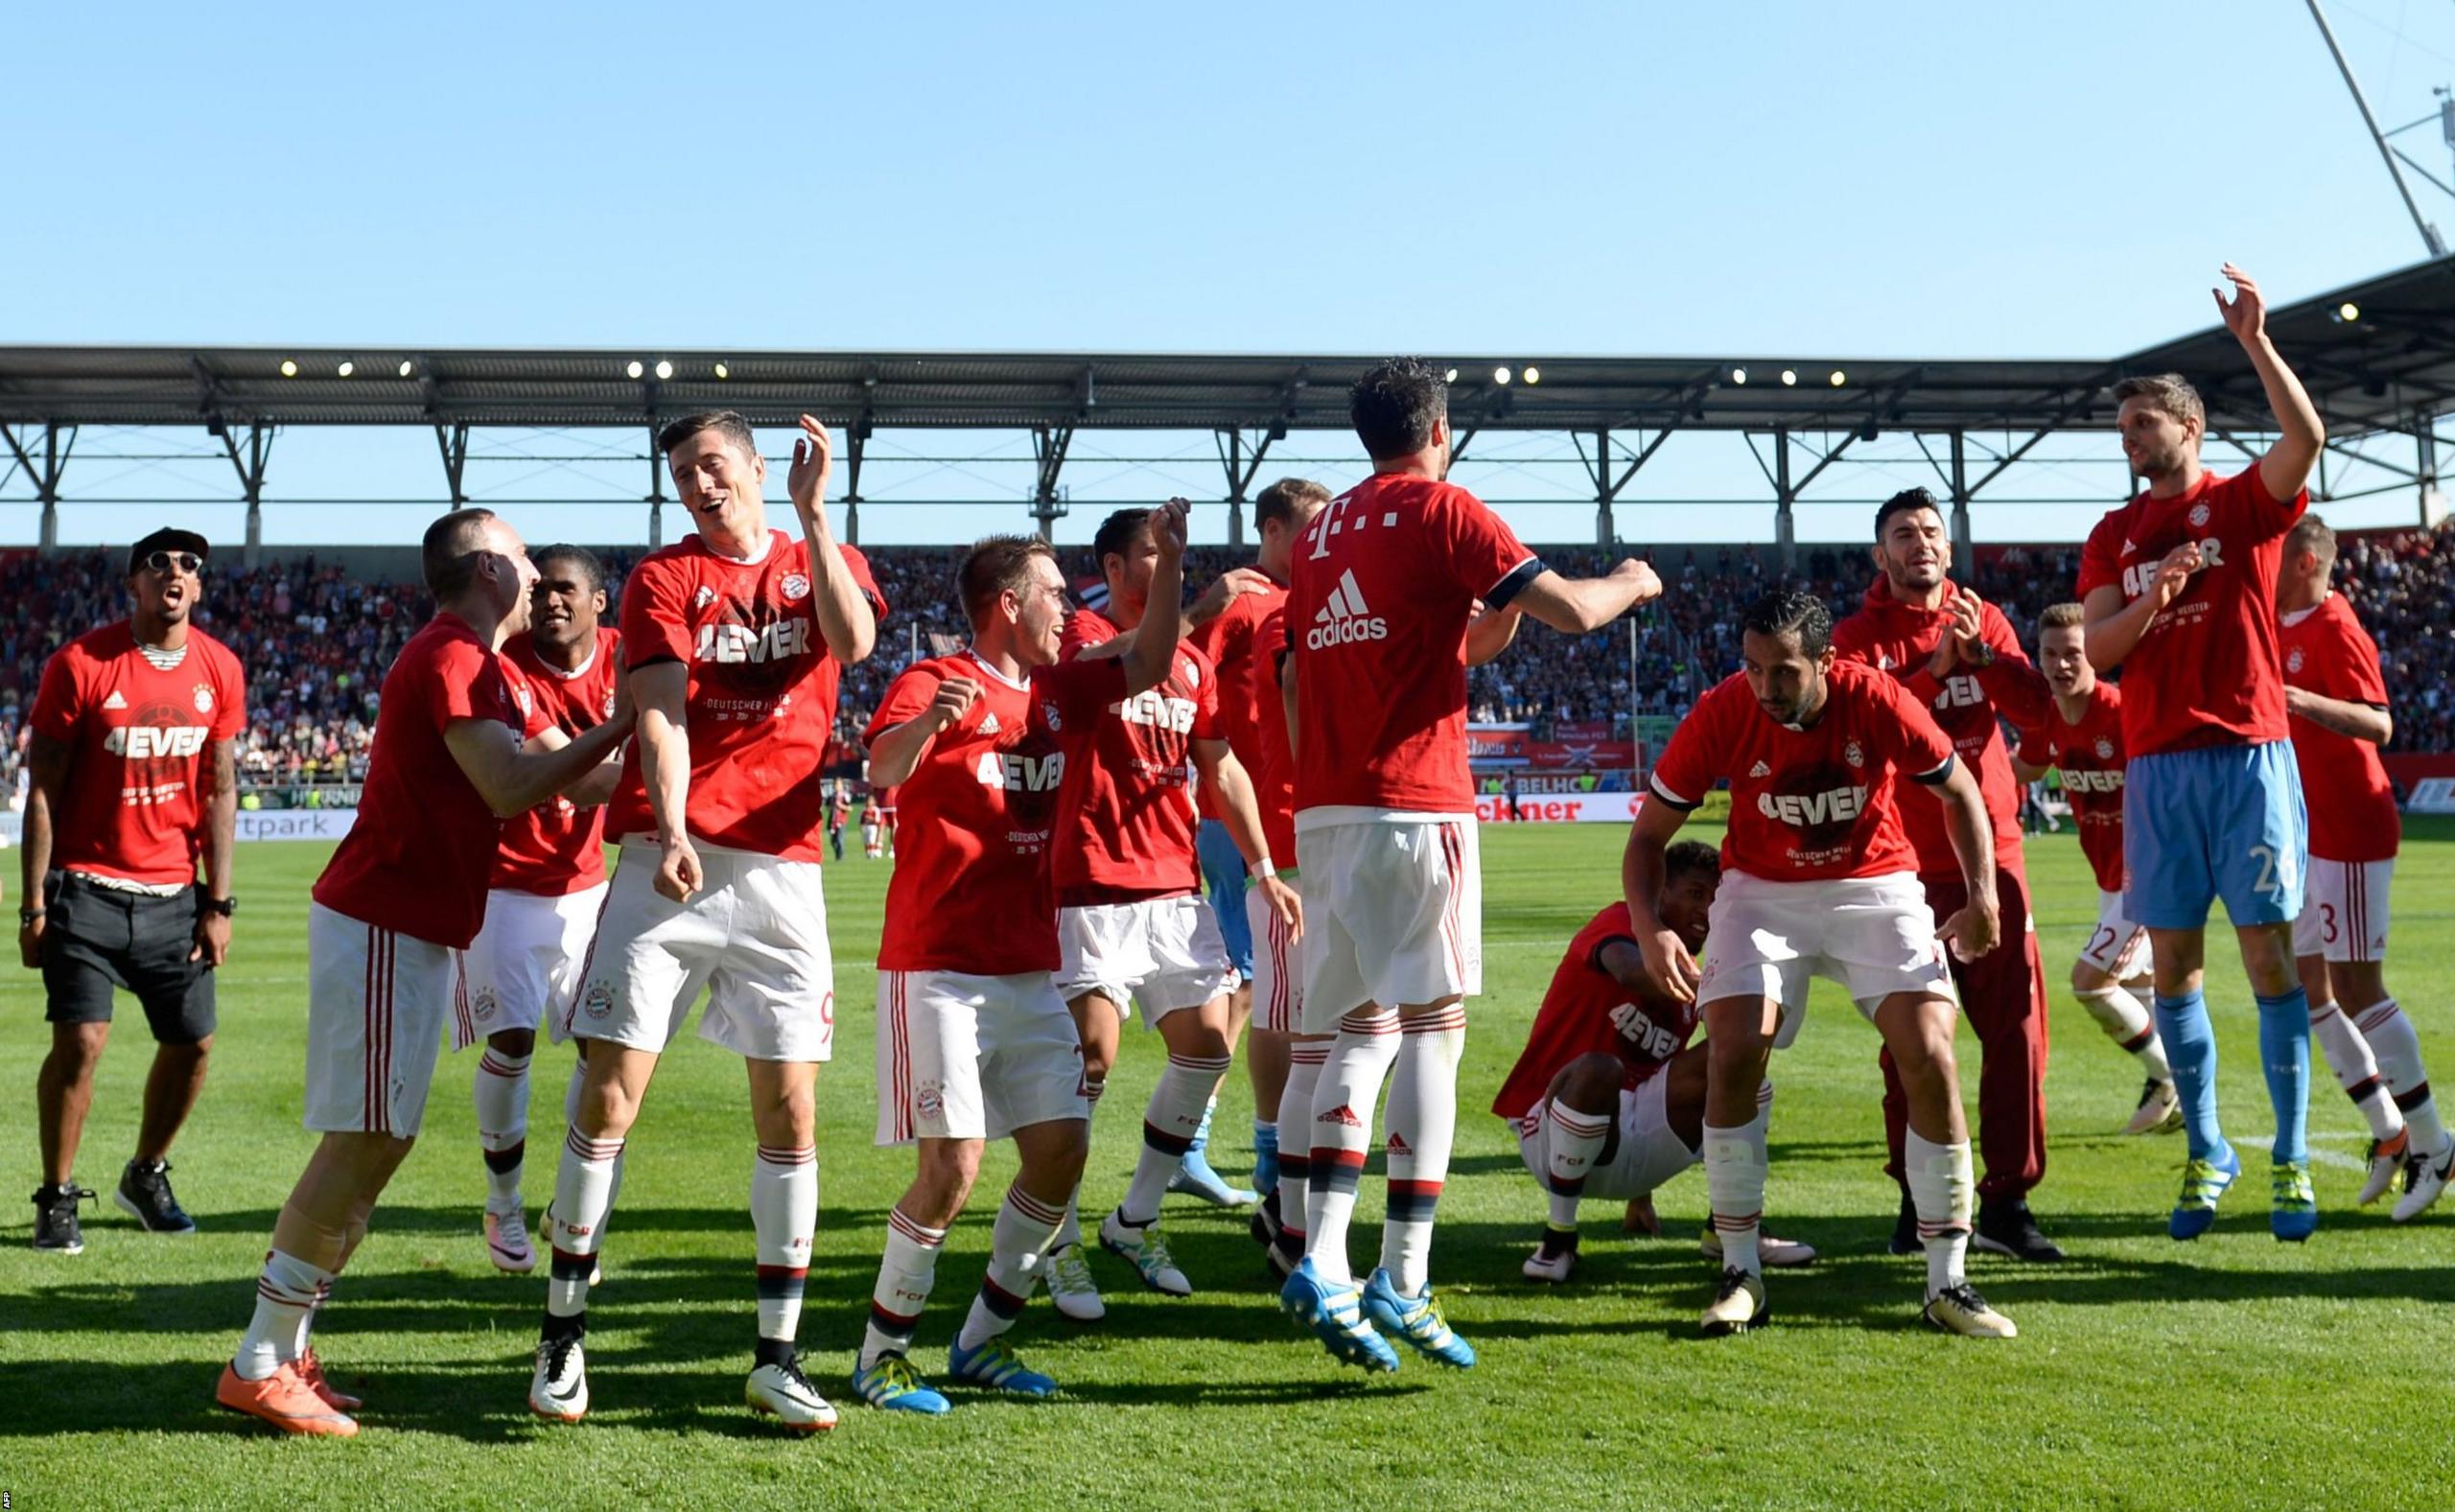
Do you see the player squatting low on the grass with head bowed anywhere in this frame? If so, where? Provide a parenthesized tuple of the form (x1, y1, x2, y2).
(1492, 840, 1816, 1281)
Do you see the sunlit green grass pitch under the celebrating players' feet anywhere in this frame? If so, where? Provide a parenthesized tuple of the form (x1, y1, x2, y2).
(0, 825, 2455, 1509)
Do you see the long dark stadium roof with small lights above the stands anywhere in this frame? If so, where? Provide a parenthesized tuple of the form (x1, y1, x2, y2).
(14, 260, 2455, 432)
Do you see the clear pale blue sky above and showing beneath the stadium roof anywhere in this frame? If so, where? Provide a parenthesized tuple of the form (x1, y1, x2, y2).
(0, 0, 2455, 552)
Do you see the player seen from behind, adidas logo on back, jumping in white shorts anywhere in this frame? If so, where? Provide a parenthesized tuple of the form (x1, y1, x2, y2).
(1279, 359, 1662, 1370)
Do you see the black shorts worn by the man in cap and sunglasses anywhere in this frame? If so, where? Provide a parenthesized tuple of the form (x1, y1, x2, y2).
(42, 872, 214, 1046)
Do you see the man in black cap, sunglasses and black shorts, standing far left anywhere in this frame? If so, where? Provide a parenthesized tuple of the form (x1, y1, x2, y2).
(17, 530, 248, 1254)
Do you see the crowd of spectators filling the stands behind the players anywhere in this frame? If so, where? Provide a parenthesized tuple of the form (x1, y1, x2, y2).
(14, 525, 2455, 790)
